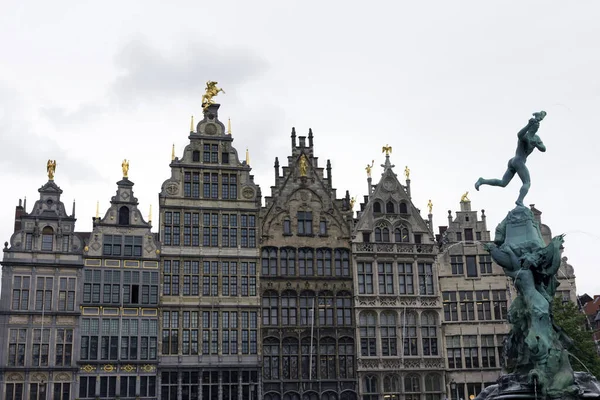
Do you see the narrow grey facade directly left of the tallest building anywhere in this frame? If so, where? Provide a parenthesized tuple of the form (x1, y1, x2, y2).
(77, 177, 160, 400)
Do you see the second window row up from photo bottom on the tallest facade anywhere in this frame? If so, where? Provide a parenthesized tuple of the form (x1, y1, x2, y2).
(162, 310, 258, 355)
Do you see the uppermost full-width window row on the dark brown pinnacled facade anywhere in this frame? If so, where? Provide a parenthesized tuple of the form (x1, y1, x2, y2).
(261, 247, 350, 277)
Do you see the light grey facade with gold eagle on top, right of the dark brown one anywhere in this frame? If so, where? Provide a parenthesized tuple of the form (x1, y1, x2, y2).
(352, 155, 445, 400)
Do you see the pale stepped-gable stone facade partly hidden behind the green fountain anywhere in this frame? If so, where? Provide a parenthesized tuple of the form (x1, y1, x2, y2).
(438, 201, 576, 400)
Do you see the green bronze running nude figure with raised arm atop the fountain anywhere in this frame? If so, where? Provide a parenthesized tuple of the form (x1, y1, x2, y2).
(475, 111, 546, 206)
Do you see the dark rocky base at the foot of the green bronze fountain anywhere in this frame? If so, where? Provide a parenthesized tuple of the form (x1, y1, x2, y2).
(475, 372, 600, 400)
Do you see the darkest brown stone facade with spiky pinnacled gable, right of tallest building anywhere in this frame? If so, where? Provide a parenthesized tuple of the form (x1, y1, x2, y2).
(260, 130, 357, 400)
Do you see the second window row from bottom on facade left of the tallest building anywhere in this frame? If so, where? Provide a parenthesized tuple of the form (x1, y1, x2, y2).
(80, 318, 158, 360)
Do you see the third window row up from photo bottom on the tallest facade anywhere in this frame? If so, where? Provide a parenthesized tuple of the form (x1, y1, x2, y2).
(163, 260, 257, 297)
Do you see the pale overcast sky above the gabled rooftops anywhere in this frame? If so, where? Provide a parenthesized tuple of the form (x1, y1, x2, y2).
(0, 0, 600, 294)
